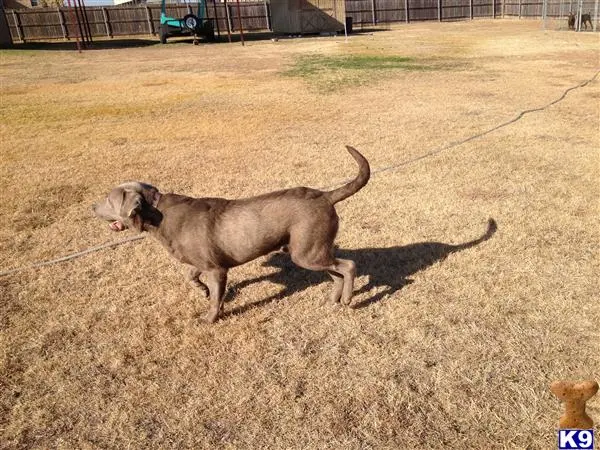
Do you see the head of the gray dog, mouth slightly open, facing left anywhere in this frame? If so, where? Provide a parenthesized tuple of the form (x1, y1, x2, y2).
(92, 181, 160, 232)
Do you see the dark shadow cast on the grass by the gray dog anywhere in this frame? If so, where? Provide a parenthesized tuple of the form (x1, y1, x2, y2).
(225, 219, 497, 315)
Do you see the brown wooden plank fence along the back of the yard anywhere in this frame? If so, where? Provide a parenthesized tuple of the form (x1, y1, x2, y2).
(5, 0, 595, 42)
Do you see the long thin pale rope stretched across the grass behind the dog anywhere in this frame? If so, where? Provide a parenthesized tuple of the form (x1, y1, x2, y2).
(0, 70, 600, 277)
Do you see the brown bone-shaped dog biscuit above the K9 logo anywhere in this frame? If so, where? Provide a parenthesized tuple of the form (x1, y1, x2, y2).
(550, 380, 598, 430)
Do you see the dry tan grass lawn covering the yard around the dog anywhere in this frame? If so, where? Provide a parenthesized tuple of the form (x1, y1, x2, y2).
(0, 21, 600, 449)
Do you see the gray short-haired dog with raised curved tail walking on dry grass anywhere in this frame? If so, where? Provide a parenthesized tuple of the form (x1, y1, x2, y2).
(93, 146, 370, 323)
